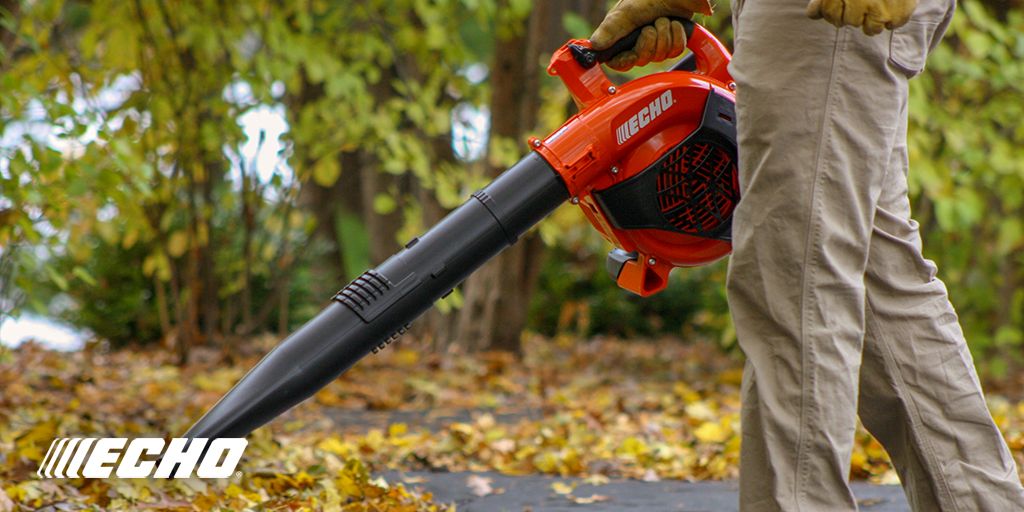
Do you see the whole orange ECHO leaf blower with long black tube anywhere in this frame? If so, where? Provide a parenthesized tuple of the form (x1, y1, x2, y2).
(185, 19, 739, 438)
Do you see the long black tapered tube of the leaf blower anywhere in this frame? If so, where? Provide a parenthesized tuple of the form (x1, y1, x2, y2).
(185, 153, 568, 438)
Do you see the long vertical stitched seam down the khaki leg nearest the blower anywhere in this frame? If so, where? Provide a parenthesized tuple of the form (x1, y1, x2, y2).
(794, 24, 845, 511)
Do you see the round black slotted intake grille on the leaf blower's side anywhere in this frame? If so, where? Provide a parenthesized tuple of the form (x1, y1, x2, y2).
(657, 140, 739, 238)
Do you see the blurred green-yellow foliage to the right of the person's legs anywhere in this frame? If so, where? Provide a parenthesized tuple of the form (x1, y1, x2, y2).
(908, 0, 1024, 374)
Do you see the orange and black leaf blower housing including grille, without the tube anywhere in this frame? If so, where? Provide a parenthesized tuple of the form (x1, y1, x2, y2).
(529, 19, 739, 296)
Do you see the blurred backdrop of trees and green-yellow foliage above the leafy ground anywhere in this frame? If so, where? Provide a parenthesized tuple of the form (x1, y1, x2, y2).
(0, 0, 1024, 376)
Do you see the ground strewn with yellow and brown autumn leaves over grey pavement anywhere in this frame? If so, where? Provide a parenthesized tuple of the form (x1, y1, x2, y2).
(0, 337, 1024, 512)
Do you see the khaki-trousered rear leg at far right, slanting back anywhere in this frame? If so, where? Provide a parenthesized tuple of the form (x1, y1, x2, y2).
(859, 101, 1024, 512)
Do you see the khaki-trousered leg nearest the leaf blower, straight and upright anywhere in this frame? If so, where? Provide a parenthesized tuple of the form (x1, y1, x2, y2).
(728, 0, 933, 512)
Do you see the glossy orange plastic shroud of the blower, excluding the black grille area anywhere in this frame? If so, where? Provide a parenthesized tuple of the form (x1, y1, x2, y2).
(529, 25, 735, 296)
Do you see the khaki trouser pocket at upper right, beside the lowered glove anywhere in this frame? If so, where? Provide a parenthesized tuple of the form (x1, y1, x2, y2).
(889, 0, 956, 78)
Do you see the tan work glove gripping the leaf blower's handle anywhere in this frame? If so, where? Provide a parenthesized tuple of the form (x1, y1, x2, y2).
(590, 0, 712, 71)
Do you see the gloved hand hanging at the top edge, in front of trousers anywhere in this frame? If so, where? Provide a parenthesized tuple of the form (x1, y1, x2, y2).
(807, 0, 918, 36)
